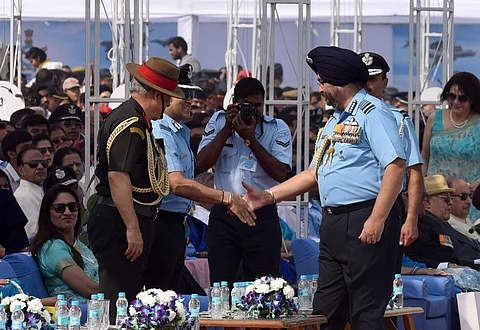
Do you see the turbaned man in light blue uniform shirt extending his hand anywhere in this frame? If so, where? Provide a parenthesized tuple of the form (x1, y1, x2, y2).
(244, 47, 406, 330)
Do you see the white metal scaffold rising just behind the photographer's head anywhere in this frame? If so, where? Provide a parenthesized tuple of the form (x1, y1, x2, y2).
(225, 0, 262, 88)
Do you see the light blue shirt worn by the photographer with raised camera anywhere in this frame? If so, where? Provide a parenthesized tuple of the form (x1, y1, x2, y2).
(198, 110, 292, 194)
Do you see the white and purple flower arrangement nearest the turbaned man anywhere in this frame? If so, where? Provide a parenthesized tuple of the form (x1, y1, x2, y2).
(236, 276, 298, 319)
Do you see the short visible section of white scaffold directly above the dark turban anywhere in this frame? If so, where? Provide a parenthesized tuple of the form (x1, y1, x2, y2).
(330, 0, 363, 53)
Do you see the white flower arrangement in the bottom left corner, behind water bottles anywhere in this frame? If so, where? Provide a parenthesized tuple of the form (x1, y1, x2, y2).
(1, 293, 55, 330)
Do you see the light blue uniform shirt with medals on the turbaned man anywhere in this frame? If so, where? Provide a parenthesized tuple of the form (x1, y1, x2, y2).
(310, 89, 406, 207)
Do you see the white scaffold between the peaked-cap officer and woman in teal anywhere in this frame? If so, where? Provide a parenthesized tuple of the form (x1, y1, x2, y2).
(408, 0, 454, 136)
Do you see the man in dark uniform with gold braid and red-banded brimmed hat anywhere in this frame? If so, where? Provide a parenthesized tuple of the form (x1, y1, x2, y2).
(88, 57, 184, 321)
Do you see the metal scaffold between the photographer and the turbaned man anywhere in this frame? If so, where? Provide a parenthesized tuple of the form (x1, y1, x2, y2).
(261, 0, 312, 237)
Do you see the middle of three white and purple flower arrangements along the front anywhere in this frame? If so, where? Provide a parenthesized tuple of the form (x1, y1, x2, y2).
(117, 289, 195, 330)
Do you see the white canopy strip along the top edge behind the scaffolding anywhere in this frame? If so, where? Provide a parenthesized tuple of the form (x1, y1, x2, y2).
(0, 0, 480, 23)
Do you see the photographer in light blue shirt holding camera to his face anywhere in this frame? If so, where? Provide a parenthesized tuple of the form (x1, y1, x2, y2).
(197, 78, 292, 285)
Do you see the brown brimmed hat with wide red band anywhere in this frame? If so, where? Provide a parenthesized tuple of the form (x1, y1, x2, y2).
(127, 57, 184, 99)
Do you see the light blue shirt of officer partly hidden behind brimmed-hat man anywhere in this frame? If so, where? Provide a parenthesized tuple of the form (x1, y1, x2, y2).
(152, 113, 195, 213)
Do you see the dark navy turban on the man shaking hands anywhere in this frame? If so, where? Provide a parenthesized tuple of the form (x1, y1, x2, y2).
(307, 46, 369, 86)
